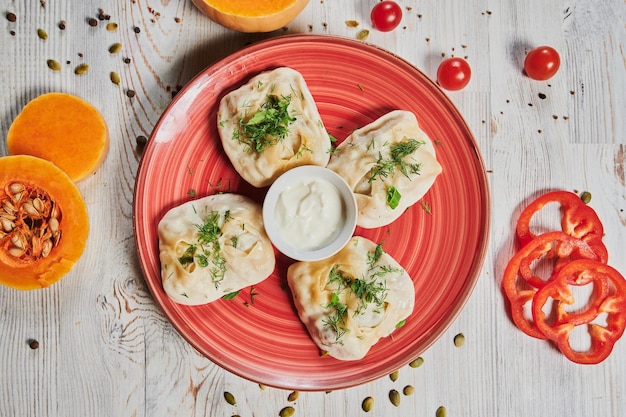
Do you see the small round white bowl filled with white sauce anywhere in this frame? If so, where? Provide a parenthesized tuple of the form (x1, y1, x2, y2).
(263, 165, 357, 261)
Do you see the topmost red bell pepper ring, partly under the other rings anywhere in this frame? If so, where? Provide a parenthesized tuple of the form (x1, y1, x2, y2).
(516, 191, 608, 263)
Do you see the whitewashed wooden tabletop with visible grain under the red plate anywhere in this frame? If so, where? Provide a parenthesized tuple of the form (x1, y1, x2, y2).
(0, 0, 626, 417)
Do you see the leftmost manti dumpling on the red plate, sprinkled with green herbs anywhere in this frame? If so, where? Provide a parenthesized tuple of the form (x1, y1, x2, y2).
(158, 194, 276, 305)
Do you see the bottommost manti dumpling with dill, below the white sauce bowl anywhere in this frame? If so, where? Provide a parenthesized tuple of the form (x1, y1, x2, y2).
(287, 236, 415, 360)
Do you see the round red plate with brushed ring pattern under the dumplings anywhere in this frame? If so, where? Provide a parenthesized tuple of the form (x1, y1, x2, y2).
(134, 35, 490, 390)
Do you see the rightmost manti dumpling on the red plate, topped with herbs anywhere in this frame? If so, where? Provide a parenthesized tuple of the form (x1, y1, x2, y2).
(328, 110, 442, 229)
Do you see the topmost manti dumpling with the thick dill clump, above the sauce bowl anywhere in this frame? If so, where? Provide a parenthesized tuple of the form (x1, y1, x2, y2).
(217, 67, 331, 187)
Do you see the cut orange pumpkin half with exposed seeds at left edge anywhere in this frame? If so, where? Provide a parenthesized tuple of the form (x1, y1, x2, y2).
(0, 155, 89, 290)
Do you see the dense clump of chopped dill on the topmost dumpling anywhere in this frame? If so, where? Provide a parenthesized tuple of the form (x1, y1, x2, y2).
(233, 95, 296, 153)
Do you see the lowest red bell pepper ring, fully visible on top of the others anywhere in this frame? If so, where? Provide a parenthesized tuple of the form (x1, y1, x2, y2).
(532, 259, 626, 364)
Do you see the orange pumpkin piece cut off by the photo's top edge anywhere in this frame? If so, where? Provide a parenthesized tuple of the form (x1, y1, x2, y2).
(192, 0, 309, 32)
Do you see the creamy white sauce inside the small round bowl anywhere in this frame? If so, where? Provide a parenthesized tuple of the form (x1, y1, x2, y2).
(274, 177, 346, 250)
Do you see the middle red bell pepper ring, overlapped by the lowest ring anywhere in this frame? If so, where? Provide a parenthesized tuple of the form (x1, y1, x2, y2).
(502, 231, 598, 339)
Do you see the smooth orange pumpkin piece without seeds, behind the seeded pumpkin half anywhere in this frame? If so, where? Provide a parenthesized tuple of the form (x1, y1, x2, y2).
(7, 93, 109, 181)
